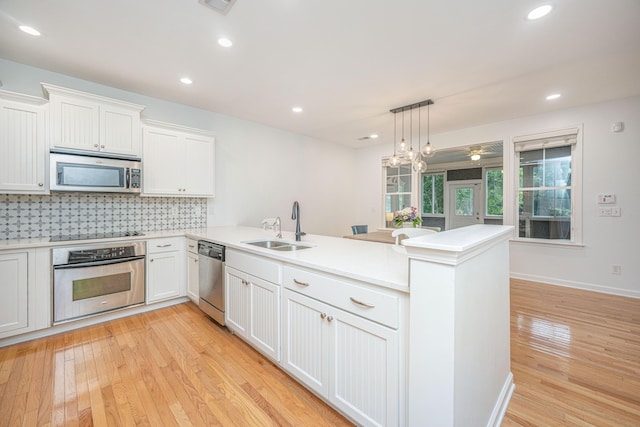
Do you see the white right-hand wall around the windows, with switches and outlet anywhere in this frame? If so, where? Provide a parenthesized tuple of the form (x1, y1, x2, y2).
(356, 96, 640, 298)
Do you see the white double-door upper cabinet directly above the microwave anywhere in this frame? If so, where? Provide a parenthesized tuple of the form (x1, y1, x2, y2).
(42, 84, 144, 157)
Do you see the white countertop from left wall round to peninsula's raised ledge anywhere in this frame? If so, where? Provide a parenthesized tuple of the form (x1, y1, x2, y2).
(0, 225, 513, 292)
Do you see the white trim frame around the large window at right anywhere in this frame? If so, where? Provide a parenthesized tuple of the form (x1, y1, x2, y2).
(511, 125, 583, 246)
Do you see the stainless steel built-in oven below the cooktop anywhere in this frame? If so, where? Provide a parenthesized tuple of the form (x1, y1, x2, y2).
(52, 242, 146, 324)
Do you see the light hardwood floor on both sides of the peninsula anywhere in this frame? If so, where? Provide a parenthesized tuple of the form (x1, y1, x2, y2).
(0, 280, 640, 427)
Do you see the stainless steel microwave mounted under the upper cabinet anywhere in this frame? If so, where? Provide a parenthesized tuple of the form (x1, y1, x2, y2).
(49, 151, 142, 193)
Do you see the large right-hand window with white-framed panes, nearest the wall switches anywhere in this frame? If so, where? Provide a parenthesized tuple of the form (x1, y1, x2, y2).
(514, 129, 581, 243)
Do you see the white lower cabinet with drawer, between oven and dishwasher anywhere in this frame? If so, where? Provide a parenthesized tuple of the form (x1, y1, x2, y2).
(147, 237, 186, 303)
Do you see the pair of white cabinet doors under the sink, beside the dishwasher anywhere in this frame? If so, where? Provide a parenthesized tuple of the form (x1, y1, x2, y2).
(225, 266, 280, 361)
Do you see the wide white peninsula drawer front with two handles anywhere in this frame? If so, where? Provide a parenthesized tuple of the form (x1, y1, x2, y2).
(284, 266, 400, 329)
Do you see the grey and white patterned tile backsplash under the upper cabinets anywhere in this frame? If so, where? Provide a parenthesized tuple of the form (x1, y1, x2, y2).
(0, 193, 207, 240)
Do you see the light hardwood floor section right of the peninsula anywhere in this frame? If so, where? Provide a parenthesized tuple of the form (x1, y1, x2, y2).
(502, 279, 640, 427)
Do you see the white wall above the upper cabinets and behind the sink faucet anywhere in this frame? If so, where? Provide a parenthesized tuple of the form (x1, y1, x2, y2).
(0, 59, 356, 236)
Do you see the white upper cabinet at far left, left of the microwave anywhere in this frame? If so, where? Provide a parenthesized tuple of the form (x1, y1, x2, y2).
(0, 91, 48, 194)
